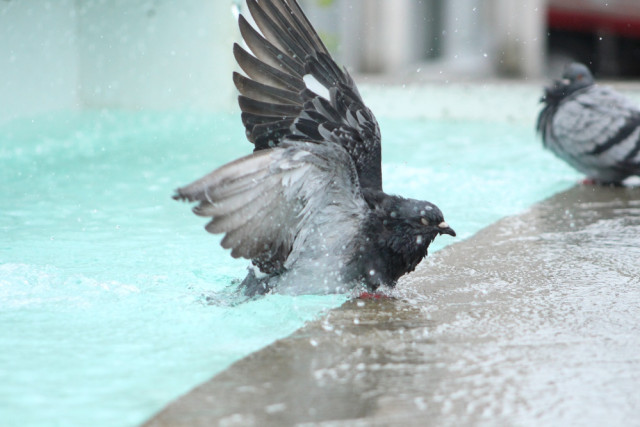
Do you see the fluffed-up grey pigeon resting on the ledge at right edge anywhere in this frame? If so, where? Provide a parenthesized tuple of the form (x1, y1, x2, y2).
(537, 63, 640, 184)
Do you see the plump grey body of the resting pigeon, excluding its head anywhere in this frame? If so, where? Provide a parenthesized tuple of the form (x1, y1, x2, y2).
(543, 85, 640, 173)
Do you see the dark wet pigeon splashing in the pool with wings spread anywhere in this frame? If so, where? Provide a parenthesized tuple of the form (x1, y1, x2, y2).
(174, 0, 455, 296)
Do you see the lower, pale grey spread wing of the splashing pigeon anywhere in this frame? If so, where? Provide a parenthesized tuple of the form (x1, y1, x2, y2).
(174, 141, 367, 273)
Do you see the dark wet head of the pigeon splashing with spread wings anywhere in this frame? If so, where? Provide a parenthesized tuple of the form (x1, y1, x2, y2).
(390, 198, 456, 239)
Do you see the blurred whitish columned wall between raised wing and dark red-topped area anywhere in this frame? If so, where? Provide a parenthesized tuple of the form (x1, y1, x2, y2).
(304, 0, 547, 78)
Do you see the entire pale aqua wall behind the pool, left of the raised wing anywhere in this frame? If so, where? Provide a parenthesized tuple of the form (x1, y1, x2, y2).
(0, 0, 239, 123)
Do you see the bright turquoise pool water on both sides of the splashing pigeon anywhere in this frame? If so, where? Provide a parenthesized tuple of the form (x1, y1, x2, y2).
(0, 112, 578, 426)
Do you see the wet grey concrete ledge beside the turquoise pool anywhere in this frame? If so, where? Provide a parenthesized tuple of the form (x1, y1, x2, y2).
(147, 186, 640, 426)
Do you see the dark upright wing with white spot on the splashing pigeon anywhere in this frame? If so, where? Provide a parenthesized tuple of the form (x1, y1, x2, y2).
(233, 0, 382, 190)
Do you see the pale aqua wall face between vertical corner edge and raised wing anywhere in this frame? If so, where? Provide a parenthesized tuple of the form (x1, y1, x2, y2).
(78, 0, 237, 109)
